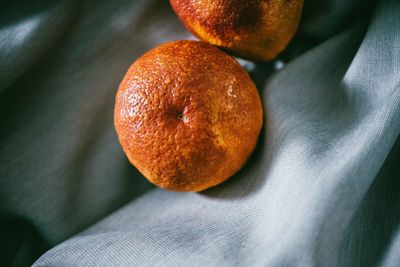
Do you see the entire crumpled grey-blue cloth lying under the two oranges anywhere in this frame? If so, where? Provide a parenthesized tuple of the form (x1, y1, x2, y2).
(0, 0, 400, 267)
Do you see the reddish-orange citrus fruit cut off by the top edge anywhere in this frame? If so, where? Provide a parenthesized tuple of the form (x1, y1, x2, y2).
(170, 0, 303, 61)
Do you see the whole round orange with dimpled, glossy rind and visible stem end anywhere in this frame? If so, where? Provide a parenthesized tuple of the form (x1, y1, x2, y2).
(114, 41, 263, 191)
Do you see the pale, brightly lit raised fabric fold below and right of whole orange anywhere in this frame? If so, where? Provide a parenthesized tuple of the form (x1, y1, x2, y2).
(34, 0, 400, 267)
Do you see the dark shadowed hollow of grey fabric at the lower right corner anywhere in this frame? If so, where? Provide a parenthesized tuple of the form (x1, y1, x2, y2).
(340, 138, 400, 266)
